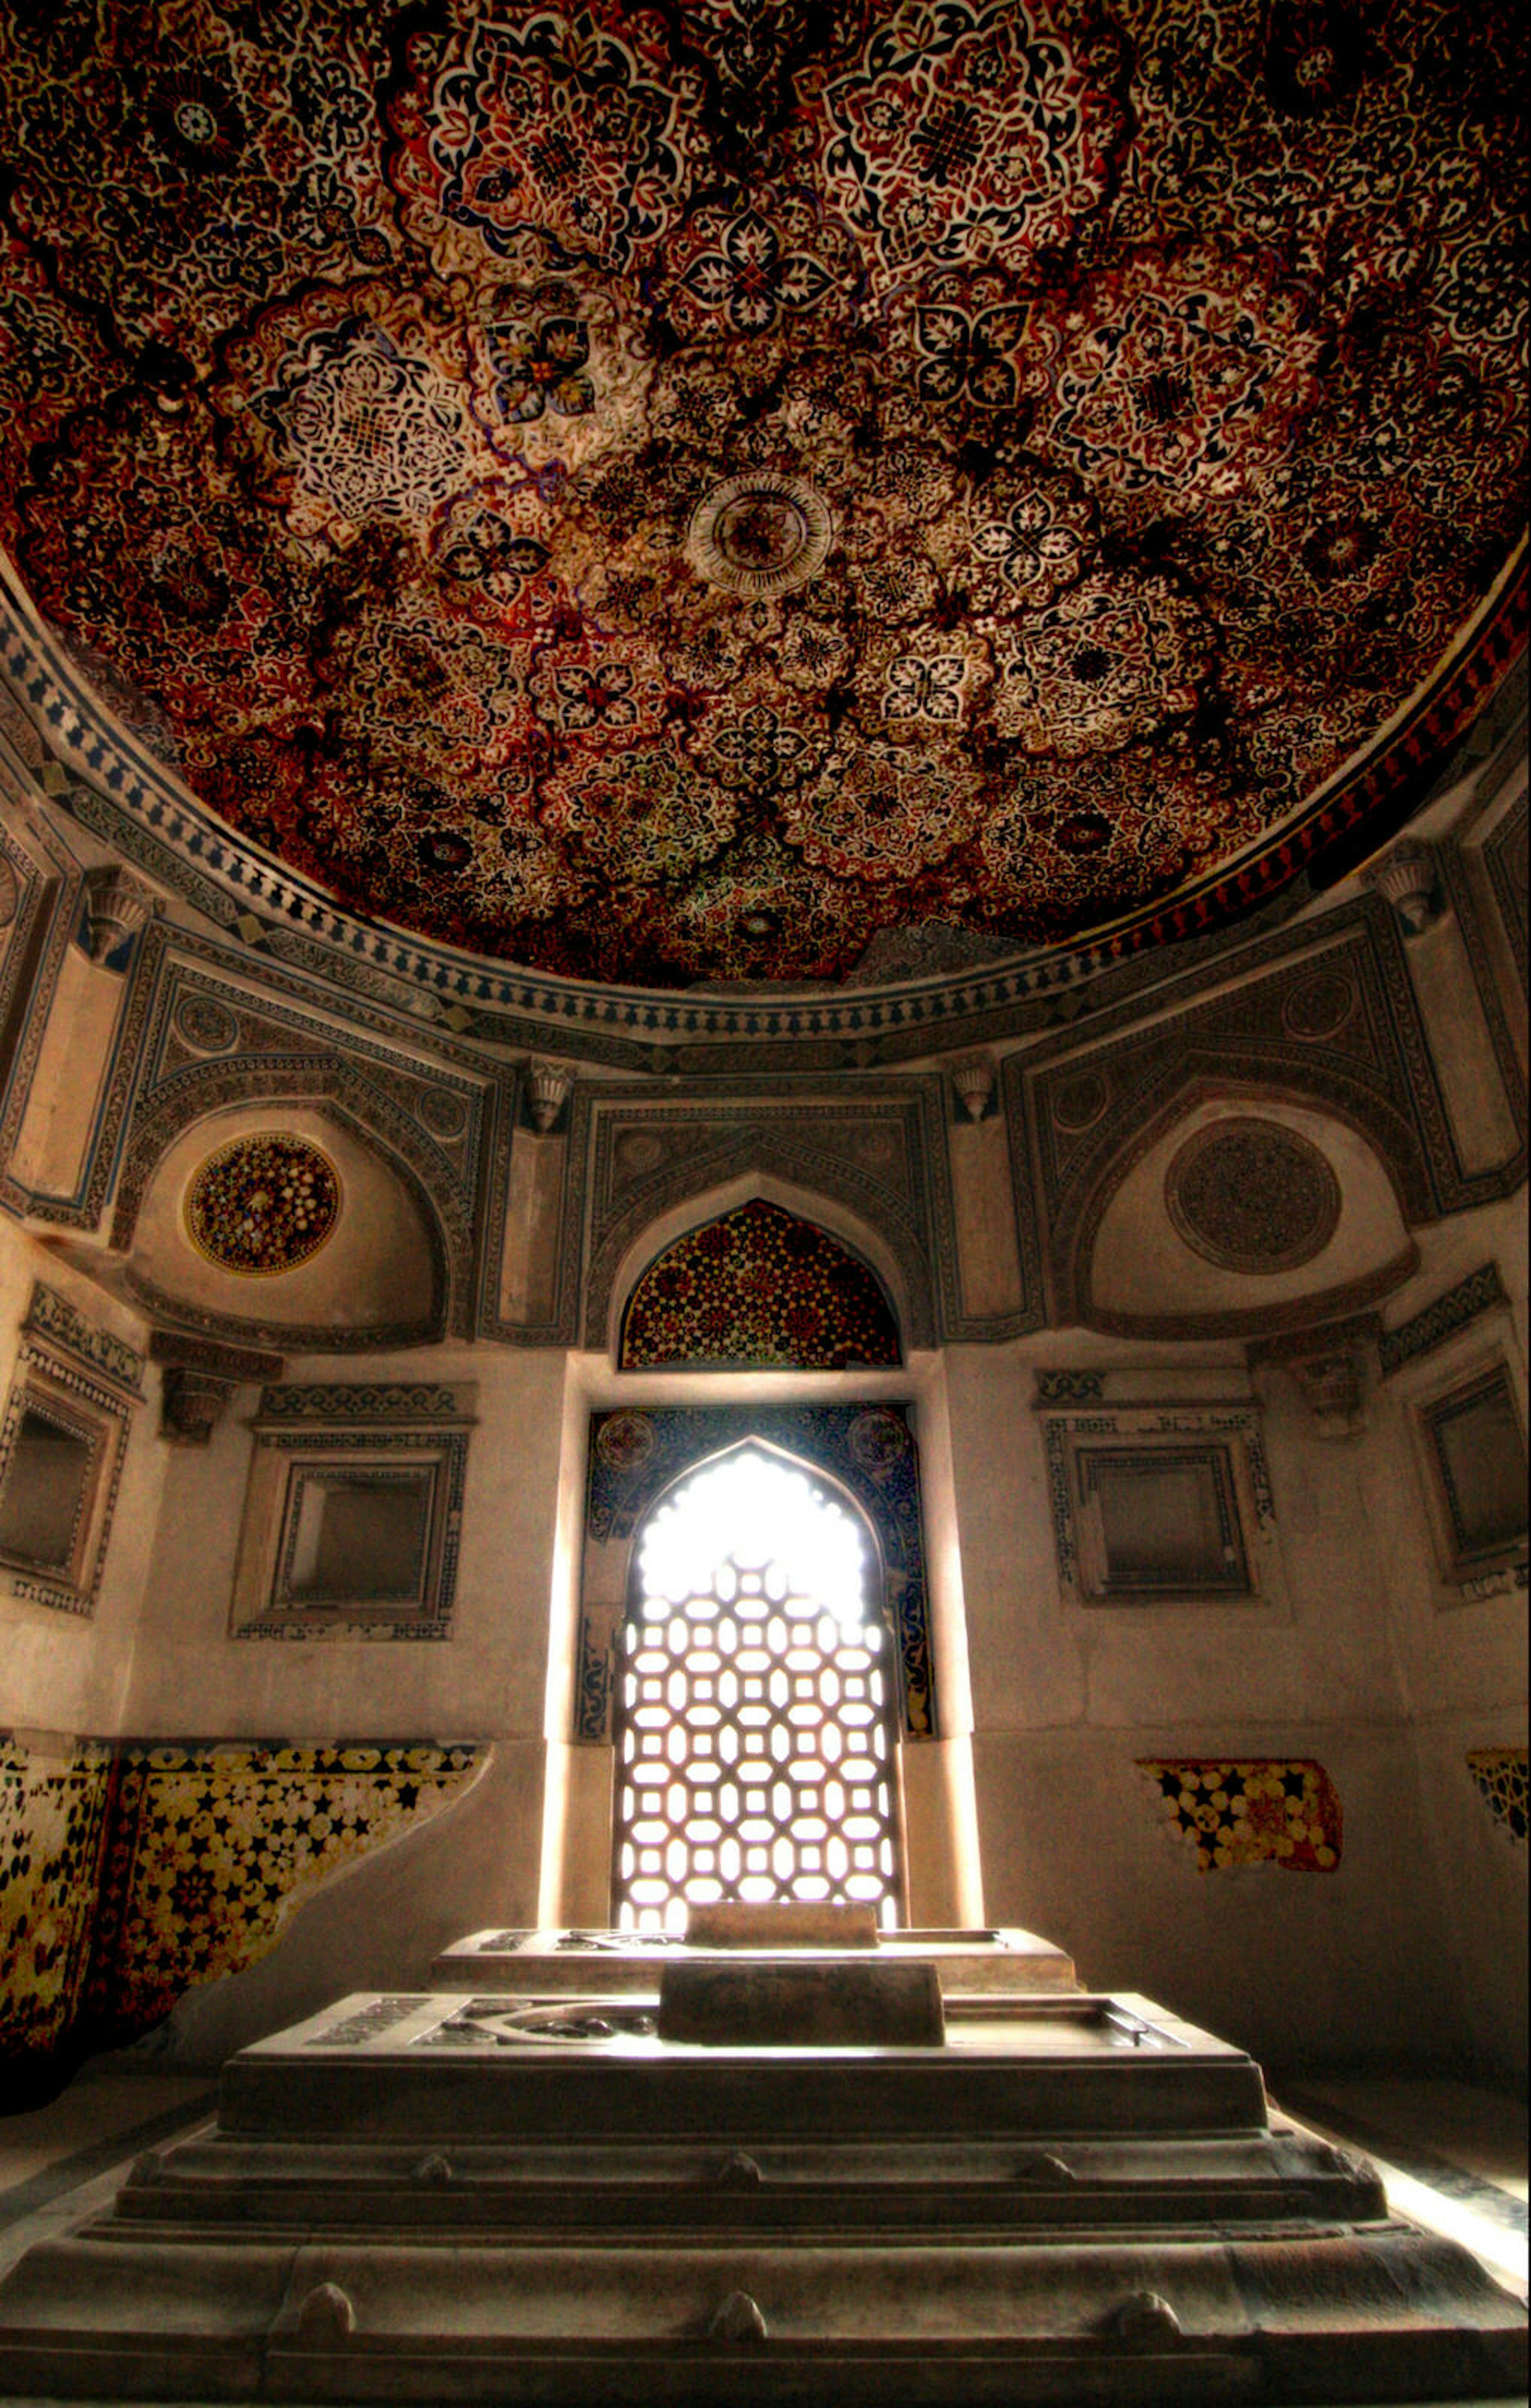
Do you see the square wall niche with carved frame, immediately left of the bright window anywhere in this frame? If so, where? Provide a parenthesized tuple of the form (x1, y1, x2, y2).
(231, 1382, 476, 1640)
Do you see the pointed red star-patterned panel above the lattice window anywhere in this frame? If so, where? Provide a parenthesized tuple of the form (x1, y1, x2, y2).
(616, 1197, 900, 1370)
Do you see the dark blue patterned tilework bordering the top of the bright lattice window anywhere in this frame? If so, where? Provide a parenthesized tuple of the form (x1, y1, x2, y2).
(573, 1404, 939, 1744)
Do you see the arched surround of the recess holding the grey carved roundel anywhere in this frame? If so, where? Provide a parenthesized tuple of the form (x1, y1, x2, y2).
(1047, 1060, 1437, 1337)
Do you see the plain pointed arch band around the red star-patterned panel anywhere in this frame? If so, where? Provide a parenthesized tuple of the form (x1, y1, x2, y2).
(585, 1160, 934, 1360)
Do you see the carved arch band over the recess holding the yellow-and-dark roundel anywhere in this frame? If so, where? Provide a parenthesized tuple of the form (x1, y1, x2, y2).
(111, 1057, 474, 1344)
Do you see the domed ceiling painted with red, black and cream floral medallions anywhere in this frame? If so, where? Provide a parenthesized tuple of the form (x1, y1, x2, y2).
(0, 0, 1526, 985)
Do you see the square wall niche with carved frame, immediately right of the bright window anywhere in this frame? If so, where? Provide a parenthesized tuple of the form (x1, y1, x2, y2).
(1035, 1372, 1278, 1606)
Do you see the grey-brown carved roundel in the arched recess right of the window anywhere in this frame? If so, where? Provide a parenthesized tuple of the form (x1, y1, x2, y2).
(1165, 1120, 1341, 1272)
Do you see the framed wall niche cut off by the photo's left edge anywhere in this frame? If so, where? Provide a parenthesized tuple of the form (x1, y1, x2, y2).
(0, 1281, 142, 1616)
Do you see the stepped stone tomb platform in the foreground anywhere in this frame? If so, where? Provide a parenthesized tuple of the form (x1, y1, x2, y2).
(0, 1919, 1526, 2408)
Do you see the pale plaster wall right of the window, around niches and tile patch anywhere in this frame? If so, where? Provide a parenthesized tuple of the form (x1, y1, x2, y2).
(946, 1199, 1526, 2076)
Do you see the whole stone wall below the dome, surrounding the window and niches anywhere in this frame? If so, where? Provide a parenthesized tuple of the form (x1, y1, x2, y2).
(0, 684, 1526, 2076)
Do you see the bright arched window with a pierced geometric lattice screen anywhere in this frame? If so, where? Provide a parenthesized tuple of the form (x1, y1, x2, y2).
(614, 1440, 903, 1931)
